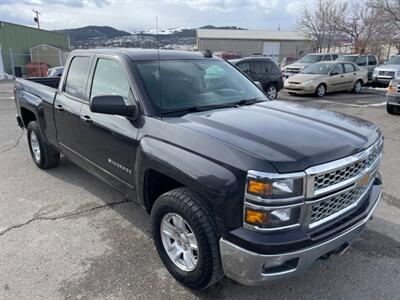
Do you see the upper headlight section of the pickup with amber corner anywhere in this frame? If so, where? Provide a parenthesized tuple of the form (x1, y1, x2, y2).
(247, 177, 304, 199)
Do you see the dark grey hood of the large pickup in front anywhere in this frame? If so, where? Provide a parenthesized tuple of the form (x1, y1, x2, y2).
(173, 101, 380, 173)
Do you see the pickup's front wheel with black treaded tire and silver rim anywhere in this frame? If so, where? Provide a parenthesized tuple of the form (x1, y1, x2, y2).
(151, 188, 224, 289)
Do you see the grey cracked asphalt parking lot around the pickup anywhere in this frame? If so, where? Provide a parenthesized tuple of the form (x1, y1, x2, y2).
(0, 83, 400, 299)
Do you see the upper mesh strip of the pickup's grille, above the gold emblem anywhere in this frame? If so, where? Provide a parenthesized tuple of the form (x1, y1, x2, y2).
(314, 143, 381, 190)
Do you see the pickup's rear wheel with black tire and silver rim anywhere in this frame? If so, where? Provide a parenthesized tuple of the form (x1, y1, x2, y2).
(27, 121, 60, 169)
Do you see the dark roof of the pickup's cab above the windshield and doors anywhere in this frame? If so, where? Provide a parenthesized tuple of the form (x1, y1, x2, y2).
(69, 48, 222, 61)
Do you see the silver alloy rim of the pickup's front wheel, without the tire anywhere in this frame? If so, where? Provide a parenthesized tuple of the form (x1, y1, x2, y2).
(160, 213, 199, 272)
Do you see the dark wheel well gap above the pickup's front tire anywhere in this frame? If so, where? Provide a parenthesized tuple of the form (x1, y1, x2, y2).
(143, 169, 183, 213)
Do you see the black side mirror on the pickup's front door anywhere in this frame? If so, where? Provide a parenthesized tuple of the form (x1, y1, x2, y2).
(90, 95, 138, 119)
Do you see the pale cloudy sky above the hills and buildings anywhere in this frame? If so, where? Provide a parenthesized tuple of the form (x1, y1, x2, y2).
(0, 0, 314, 32)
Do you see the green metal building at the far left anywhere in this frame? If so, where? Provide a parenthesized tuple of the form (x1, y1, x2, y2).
(0, 20, 70, 75)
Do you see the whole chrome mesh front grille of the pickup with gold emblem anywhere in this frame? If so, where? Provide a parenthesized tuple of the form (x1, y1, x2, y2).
(306, 139, 383, 228)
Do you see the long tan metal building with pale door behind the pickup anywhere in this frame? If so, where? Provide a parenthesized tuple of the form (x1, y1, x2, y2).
(196, 29, 313, 62)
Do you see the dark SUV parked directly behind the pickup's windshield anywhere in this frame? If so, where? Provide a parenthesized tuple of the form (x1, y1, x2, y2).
(229, 56, 283, 99)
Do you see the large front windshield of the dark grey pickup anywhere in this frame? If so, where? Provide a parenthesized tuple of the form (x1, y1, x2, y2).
(135, 59, 268, 114)
